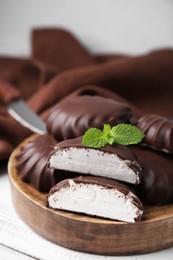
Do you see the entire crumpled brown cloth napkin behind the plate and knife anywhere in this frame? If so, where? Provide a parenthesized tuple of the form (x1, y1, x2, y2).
(0, 28, 173, 160)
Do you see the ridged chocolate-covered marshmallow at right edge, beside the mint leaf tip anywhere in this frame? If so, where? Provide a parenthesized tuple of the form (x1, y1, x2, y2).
(137, 114, 173, 154)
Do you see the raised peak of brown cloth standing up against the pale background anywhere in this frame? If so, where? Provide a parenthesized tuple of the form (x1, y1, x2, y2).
(32, 29, 96, 71)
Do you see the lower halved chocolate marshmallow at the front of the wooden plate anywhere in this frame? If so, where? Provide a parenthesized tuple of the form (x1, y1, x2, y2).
(47, 176, 143, 223)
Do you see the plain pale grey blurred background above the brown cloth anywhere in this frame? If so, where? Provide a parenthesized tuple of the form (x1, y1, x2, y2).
(0, 0, 173, 56)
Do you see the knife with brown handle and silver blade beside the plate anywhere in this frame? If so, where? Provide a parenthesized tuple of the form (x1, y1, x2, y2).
(0, 79, 46, 134)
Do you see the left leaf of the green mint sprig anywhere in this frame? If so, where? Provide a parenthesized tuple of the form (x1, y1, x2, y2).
(82, 128, 108, 148)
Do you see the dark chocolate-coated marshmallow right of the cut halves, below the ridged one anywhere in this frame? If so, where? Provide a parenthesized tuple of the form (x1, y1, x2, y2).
(131, 146, 173, 205)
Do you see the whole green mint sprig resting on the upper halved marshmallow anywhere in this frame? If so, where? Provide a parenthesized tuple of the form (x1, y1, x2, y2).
(82, 124, 145, 148)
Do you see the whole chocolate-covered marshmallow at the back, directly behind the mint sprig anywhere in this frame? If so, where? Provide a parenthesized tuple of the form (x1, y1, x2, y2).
(47, 95, 132, 141)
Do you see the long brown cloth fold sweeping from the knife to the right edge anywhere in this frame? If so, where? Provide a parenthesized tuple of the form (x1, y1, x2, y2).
(29, 50, 173, 116)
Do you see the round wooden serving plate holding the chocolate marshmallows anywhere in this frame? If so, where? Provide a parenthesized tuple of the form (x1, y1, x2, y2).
(8, 137, 173, 255)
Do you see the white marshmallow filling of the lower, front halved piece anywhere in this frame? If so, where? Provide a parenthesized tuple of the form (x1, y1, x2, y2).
(48, 180, 143, 223)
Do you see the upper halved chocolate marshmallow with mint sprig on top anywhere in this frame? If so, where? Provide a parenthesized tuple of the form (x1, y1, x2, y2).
(48, 137, 141, 184)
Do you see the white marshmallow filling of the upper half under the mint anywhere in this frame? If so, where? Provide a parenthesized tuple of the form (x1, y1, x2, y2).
(49, 147, 139, 184)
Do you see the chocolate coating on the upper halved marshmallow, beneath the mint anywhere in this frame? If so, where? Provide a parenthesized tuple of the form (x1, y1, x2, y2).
(48, 137, 142, 183)
